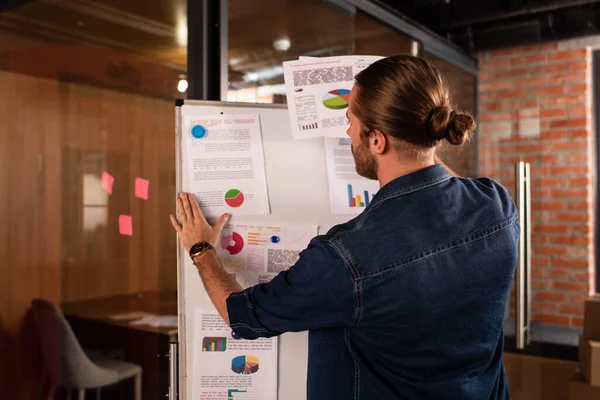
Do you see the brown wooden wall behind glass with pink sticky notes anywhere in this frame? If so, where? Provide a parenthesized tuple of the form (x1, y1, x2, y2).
(0, 71, 176, 399)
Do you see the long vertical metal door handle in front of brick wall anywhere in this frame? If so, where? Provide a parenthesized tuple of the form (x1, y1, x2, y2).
(515, 161, 531, 349)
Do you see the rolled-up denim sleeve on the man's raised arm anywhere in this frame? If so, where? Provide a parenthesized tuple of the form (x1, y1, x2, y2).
(227, 238, 357, 339)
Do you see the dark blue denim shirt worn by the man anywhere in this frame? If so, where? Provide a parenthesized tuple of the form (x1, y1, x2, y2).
(227, 165, 519, 400)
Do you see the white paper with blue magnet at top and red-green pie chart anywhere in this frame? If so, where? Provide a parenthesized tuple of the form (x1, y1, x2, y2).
(183, 114, 269, 217)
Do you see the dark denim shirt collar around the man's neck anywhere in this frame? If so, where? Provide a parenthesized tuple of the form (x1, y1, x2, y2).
(368, 164, 452, 208)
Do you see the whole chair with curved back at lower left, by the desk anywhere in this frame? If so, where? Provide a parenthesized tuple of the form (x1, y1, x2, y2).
(31, 299, 142, 400)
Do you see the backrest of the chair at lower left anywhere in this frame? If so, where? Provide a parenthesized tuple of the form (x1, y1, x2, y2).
(31, 299, 95, 390)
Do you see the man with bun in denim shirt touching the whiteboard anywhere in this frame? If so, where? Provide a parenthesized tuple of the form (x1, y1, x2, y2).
(171, 56, 519, 400)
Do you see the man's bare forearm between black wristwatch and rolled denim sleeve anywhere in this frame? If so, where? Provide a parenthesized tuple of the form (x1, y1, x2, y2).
(194, 250, 243, 326)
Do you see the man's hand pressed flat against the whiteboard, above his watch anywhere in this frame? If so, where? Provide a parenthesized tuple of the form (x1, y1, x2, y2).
(171, 193, 229, 251)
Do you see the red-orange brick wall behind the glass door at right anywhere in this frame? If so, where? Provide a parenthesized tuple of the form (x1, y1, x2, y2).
(479, 41, 594, 326)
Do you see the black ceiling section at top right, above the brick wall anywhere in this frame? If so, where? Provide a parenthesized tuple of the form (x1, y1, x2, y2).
(372, 0, 600, 53)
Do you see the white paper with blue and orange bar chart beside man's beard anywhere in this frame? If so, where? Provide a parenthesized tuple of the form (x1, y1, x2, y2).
(325, 138, 379, 215)
